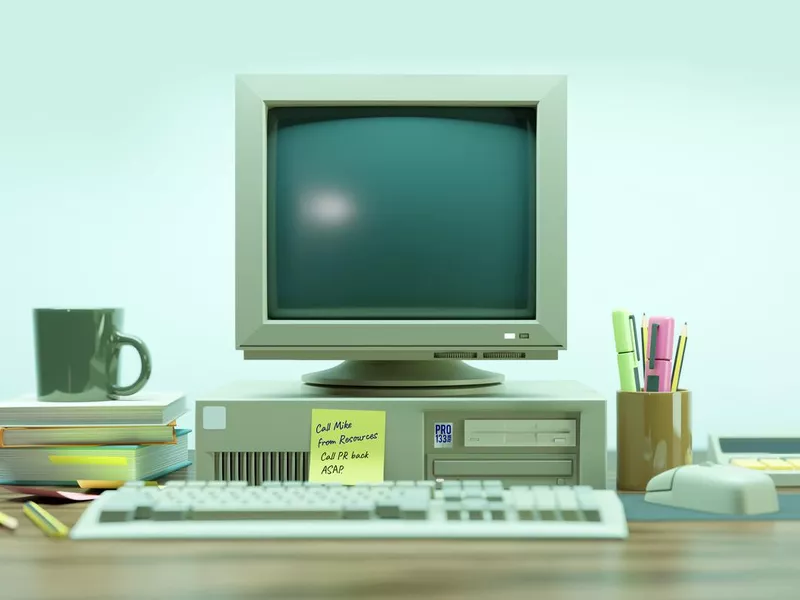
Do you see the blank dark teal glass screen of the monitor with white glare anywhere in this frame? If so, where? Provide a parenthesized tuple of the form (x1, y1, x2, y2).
(266, 106, 536, 320)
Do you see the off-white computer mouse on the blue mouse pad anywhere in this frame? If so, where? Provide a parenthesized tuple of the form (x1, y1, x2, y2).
(644, 464, 779, 515)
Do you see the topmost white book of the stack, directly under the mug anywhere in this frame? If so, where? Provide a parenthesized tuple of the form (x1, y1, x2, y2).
(0, 392, 187, 427)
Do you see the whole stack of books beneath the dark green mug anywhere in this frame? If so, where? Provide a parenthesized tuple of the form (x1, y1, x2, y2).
(0, 393, 189, 485)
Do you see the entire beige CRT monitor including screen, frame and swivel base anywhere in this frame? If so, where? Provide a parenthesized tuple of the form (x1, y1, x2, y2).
(236, 75, 567, 390)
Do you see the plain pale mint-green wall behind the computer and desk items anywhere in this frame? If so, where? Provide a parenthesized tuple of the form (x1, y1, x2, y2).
(0, 0, 800, 445)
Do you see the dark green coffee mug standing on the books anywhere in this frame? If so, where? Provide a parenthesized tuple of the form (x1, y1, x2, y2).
(33, 308, 152, 402)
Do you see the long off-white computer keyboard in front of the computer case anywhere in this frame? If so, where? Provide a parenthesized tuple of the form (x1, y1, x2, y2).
(70, 480, 628, 540)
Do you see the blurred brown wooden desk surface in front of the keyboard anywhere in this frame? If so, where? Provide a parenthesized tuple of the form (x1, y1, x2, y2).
(0, 473, 800, 600)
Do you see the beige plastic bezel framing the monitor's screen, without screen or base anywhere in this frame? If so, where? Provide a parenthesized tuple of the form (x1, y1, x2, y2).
(235, 75, 567, 360)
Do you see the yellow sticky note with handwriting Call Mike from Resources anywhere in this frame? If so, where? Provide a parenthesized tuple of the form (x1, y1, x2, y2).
(308, 408, 386, 485)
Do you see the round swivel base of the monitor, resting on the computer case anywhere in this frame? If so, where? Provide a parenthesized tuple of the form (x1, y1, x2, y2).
(303, 360, 504, 391)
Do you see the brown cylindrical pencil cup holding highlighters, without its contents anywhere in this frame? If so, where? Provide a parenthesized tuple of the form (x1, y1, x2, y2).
(617, 390, 692, 492)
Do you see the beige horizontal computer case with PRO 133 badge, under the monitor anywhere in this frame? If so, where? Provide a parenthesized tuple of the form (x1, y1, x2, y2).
(195, 381, 606, 489)
